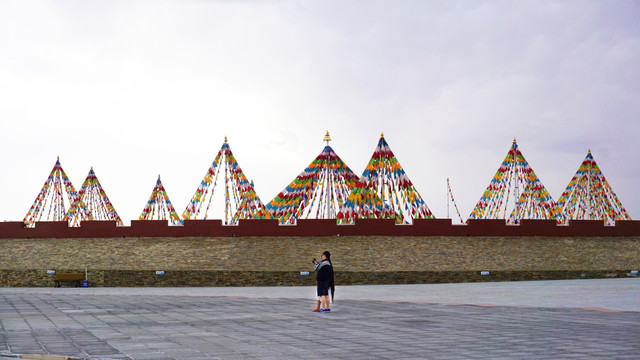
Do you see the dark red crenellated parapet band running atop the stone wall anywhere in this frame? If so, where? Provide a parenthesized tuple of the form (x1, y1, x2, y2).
(0, 219, 640, 239)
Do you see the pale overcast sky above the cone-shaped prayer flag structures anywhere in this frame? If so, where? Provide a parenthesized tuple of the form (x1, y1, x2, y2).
(0, 0, 640, 224)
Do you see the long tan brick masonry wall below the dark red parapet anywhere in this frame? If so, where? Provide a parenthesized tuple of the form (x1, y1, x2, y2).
(0, 236, 640, 286)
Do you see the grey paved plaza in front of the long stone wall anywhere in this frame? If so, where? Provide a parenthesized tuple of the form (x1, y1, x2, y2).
(0, 278, 640, 359)
